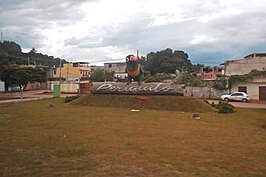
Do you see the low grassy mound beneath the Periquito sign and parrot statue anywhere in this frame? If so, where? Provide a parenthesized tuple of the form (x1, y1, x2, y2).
(71, 95, 215, 112)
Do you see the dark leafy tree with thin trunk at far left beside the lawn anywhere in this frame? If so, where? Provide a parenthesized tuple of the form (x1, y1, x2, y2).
(2, 65, 46, 99)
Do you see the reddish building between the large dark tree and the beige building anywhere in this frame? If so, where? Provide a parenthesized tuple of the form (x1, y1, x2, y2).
(196, 66, 224, 80)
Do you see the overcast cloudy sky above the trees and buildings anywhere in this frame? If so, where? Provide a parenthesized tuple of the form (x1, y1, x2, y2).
(0, 0, 266, 65)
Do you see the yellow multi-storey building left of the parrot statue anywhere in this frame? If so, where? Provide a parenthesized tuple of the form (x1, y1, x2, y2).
(53, 62, 91, 80)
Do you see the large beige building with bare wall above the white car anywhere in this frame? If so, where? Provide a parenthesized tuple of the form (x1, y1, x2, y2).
(223, 53, 266, 76)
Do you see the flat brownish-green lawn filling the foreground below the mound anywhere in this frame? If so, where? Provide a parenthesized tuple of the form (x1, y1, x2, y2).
(0, 99, 266, 177)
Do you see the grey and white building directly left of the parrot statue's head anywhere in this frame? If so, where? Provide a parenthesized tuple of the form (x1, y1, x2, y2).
(104, 62, 128, 80)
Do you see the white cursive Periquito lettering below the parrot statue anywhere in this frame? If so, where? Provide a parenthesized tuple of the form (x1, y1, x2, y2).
(97, 83, 173, 93)
